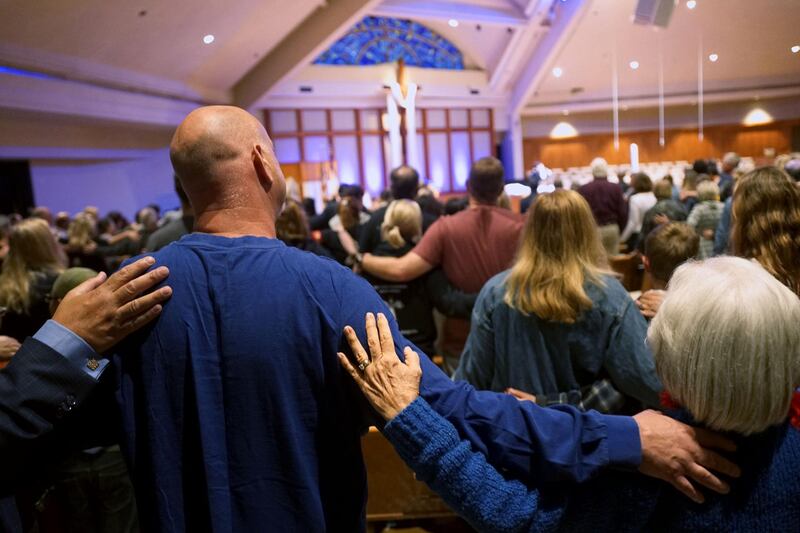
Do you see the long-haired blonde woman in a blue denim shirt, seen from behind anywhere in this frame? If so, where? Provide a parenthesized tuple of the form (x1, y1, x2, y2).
(454, 190, 661, 412)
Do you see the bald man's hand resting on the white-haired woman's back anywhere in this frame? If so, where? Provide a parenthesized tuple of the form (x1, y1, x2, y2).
(633, 410, 741, 503)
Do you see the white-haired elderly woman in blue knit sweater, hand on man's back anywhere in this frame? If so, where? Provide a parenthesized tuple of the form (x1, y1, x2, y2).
(340, 257, 800, 531)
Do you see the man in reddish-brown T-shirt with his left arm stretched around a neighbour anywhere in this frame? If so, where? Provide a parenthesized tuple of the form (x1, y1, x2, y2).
(361, 157, 524, 368)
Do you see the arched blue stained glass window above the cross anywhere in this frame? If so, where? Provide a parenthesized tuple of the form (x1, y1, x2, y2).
(314, 17, 464, 70)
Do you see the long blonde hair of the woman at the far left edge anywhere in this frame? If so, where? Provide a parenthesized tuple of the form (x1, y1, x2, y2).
(0, 218, 64, 314)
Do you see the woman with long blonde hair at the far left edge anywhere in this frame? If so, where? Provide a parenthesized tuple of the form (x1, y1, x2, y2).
(0, 218, 65, 341)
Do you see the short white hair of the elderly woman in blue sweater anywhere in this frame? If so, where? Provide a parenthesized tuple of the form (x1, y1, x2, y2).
(647, 257, 800, 435)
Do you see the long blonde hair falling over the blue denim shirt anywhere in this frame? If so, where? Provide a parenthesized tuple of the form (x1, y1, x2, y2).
(504, 190, 606, 324)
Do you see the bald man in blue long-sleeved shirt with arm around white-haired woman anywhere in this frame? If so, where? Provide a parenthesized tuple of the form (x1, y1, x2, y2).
(118, 106, 744, 532)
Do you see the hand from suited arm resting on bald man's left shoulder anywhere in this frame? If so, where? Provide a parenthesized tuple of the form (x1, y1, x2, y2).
(53, 257, 172, 353)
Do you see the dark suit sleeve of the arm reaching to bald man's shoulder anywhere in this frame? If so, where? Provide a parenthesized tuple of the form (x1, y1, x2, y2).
(0, 338, 97, 454)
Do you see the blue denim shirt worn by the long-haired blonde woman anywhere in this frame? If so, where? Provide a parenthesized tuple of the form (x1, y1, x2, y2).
(454, 271, 662, 406)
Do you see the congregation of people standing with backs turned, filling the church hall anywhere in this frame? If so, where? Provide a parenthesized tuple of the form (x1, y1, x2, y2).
(0, 107, 800, 532)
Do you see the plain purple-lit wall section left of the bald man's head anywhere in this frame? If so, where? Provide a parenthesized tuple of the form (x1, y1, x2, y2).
(31, 148, 180, 218)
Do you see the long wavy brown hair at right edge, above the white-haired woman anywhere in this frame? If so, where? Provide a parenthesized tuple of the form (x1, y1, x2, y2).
(731, 167, 800, 295)
